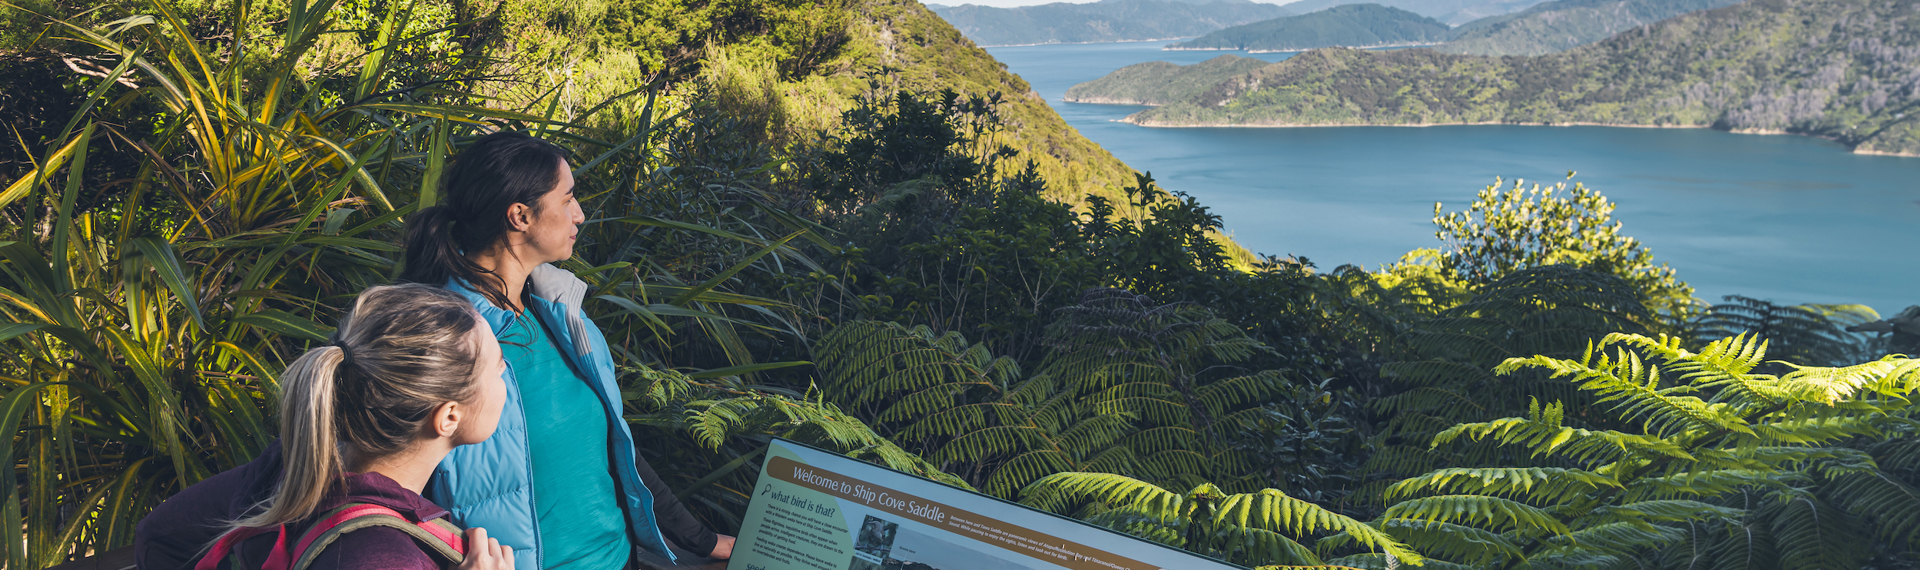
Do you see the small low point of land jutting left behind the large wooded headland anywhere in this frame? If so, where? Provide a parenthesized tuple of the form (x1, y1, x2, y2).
(1066, 54, 1267, 106)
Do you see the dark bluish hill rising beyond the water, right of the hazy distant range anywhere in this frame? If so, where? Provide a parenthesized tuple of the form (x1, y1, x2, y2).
(1167, 4, 1450, 52)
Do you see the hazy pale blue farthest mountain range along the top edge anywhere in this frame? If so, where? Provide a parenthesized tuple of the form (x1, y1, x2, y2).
(927, 0, 1292, 46)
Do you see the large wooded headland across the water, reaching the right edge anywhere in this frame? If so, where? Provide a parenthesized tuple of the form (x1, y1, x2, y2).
(1127, 0, 1920, 154)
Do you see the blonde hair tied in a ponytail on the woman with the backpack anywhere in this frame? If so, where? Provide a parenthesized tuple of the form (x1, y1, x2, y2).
(232, 284, 484, 528)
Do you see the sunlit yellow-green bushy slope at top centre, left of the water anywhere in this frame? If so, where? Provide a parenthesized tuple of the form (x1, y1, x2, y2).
(602, 0, 1133, 203)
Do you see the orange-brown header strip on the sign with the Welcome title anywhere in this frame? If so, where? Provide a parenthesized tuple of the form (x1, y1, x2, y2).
(766, 455, 1160, 570)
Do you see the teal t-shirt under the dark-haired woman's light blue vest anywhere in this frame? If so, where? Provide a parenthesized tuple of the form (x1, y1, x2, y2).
(499, 313, 632, 570)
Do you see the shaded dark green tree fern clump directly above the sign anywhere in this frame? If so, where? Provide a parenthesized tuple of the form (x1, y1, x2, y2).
(814, 290, 1284, 497)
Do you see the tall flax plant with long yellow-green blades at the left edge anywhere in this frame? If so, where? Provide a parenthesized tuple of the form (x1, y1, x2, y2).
(0, 0, 522, 568)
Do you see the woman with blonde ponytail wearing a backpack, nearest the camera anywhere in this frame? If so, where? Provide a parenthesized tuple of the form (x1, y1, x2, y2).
(134, 286, 513, 570)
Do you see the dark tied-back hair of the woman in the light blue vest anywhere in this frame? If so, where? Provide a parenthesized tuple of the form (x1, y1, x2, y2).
(399, 131, 566, 307)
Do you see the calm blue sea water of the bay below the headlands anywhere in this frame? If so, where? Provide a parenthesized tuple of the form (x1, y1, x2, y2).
(989, 42, 1920, 315)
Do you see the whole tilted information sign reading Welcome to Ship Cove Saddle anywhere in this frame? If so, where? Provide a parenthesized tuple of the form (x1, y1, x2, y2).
(728, 439, 1240, 570)
